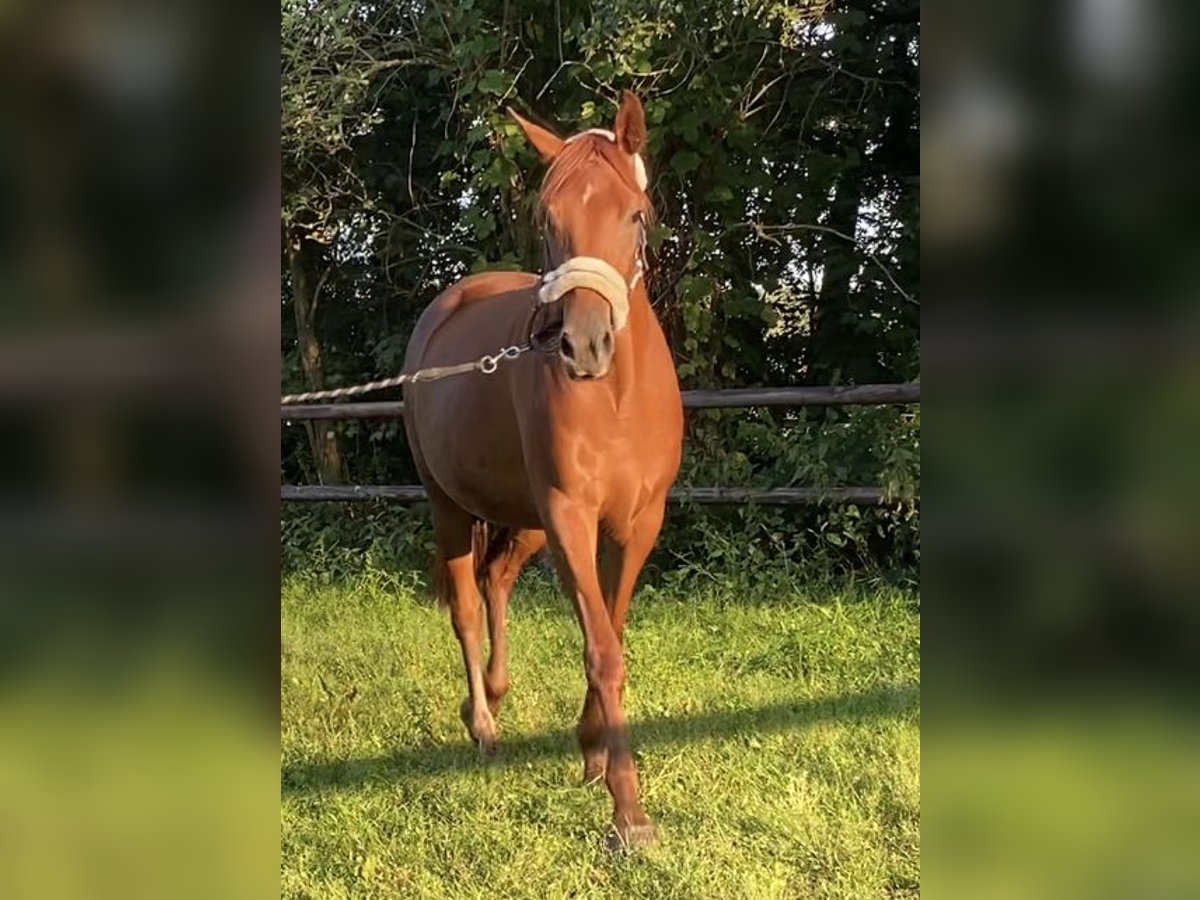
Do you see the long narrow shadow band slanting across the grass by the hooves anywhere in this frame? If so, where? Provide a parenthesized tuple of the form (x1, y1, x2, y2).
(281, 684, 920, 794)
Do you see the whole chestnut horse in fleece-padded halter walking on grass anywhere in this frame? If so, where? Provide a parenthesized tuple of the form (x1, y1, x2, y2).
(404, 91, 683, 845)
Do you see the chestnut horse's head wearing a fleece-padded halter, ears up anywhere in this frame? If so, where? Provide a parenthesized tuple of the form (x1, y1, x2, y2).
(509, 91, 650, 378)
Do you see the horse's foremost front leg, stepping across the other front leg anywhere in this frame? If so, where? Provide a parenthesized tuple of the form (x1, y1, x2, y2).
(546, 492, 654, 846)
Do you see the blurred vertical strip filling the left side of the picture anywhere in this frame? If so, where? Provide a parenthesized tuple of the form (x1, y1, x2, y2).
(0, 0, 278, 898)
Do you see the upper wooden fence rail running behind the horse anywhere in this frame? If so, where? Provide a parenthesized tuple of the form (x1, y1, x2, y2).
(280, 382, 920, 421)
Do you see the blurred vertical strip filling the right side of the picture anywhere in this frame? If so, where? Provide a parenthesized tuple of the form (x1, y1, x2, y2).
(922, 0, 1200, 898)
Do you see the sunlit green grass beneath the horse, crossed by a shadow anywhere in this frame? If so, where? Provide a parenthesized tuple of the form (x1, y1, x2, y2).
(282, 575, 920, 900)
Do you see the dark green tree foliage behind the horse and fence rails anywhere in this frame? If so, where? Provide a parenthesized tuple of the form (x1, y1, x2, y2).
(282, 0, 919, 571)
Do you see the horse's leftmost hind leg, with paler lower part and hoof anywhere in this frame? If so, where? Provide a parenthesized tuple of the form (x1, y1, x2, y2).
(430, 501, 496, 752)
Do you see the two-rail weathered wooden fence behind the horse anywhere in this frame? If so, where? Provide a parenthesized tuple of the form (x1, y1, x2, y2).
(280, 382, 920, 506)
